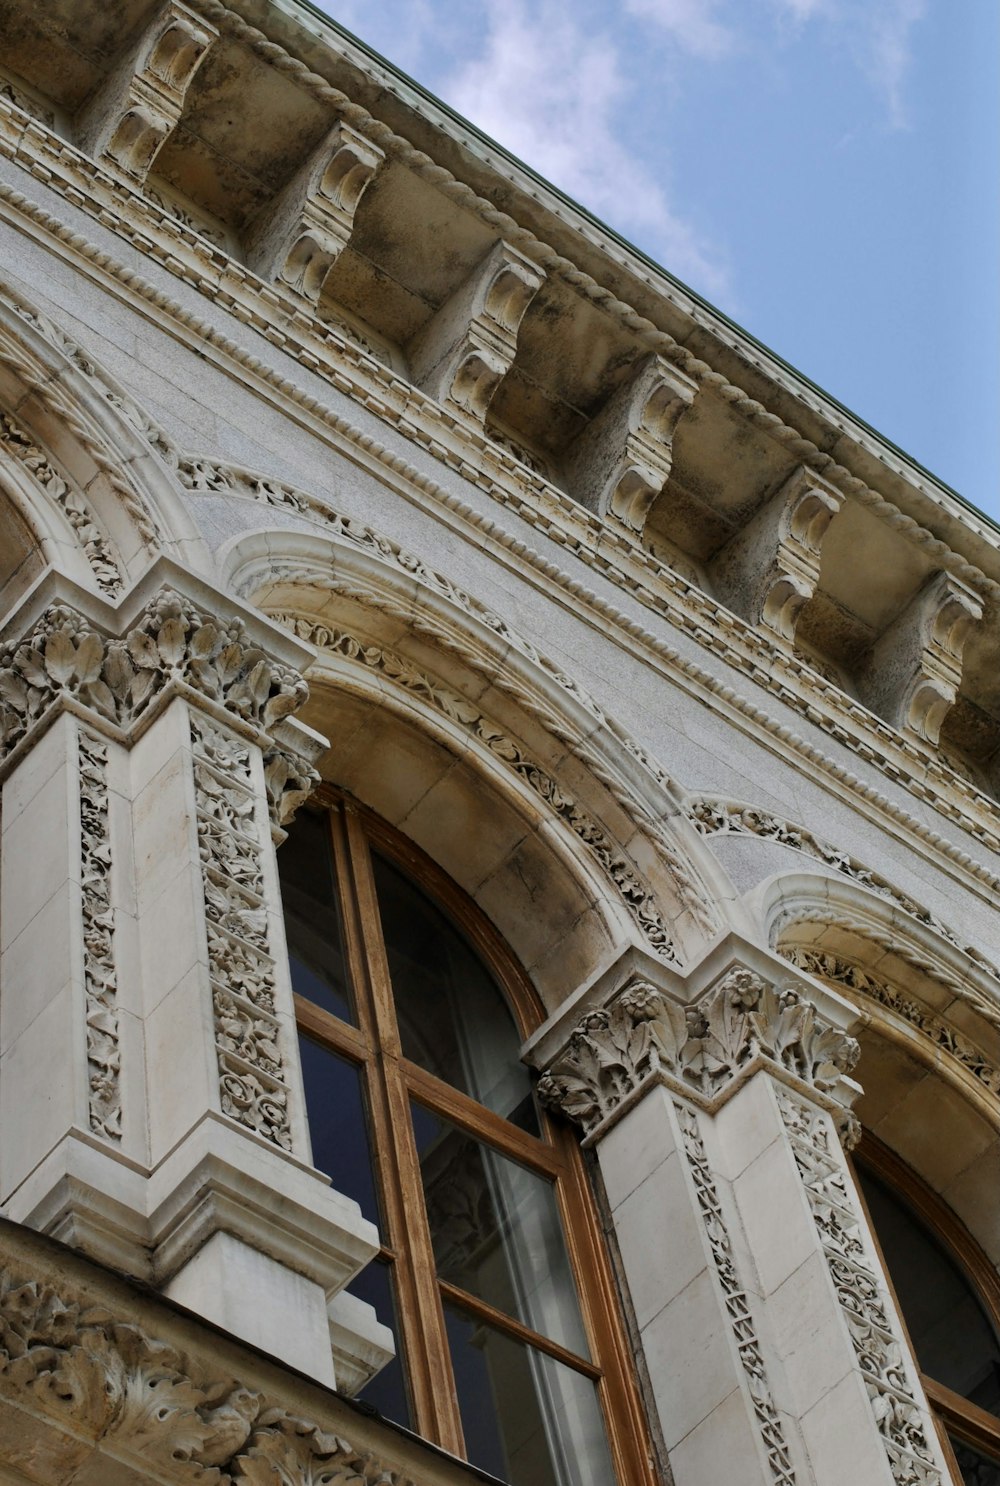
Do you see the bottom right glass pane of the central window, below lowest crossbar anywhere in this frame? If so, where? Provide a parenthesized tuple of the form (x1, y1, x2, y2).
(444, 1305, 614, 1486)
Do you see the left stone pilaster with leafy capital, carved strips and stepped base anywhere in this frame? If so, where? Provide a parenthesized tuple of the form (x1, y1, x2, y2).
(0, 562, 385, 1382)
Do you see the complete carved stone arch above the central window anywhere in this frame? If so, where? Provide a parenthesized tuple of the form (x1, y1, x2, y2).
(218, 531, 721, 1006)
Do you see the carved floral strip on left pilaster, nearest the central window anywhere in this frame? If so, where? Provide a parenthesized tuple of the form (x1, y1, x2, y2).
(192, 718, 291, 1150)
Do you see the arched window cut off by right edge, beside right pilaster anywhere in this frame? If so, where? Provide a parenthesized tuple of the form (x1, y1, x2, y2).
(856, 1135, 1000, 1486)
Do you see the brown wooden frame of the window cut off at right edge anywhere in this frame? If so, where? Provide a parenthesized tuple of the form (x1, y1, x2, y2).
(854, 1129, 1000, 1486)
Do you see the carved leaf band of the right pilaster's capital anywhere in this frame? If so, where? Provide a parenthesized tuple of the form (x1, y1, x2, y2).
(538, 966, 859, 1135)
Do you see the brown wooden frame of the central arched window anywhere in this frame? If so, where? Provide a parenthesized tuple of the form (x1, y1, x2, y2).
(286, 785, 657, 1486)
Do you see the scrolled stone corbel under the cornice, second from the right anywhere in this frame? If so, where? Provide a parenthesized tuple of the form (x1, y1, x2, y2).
(709, 467, 844, 640)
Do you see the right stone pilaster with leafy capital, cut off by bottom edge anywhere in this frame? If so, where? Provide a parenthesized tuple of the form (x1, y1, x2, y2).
(539, 954, 948, 1486)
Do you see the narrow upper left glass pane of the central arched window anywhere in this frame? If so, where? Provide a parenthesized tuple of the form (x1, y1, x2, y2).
(278, 813, 354, 1021)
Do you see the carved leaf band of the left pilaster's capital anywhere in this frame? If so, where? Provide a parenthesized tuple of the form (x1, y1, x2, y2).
(0, 588, 318, 823)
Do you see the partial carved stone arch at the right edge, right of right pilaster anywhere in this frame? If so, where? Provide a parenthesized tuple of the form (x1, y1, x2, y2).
(765, 875, 1000, 1265)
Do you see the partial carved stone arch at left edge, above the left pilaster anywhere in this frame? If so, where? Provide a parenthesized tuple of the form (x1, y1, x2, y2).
(0, 287, 207, 608)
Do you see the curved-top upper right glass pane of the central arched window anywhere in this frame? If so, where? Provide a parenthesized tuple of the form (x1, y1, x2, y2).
(371, 853, 538, 1134)
